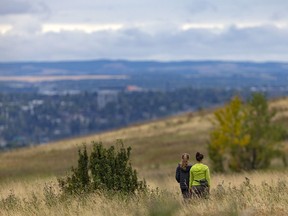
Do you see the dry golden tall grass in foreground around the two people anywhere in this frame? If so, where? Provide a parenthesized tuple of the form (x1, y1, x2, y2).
(0, 171, 288, 216)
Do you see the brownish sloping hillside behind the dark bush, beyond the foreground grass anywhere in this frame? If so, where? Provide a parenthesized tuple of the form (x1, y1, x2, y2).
(0, 98, 288, 181)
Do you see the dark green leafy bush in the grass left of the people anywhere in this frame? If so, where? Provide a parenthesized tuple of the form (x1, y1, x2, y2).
(58, 140, 146, 194)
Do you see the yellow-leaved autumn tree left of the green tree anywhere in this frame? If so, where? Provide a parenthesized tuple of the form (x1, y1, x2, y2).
(208, 96, 251, 172)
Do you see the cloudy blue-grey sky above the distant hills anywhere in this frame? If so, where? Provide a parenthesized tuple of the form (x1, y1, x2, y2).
(0, 0, 288, 62)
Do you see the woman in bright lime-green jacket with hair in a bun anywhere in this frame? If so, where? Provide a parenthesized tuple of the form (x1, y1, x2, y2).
(189, 152, 211, 197)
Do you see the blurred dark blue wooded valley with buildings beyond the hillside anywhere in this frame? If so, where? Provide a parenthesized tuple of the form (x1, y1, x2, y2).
(0, 88, 241, 150)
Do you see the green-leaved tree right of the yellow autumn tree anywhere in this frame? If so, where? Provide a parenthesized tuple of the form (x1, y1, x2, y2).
(246, 93, 286, 169)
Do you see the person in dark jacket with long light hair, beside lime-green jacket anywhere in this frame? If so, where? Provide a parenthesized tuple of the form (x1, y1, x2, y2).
(176, 153, 192, 199)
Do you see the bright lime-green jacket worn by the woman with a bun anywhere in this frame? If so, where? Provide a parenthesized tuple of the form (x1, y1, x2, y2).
(189, 163, 211, 188)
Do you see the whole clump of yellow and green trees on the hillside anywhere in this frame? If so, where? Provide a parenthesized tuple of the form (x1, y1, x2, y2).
(208, 93, 286, 172)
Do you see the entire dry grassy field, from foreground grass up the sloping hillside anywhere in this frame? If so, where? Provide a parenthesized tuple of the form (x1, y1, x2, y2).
(0, 98, 288, 215)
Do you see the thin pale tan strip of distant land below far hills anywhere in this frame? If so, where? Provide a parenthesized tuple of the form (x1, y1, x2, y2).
(0, 75, 129, 82)
